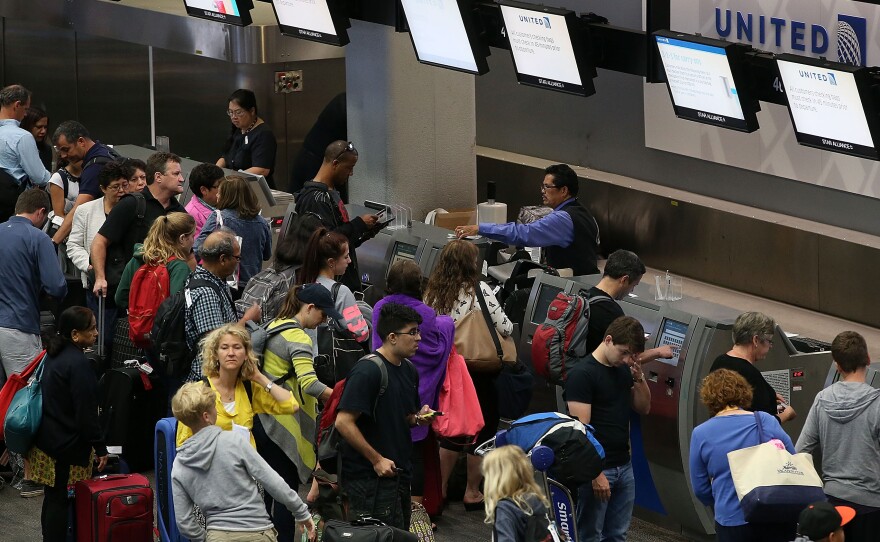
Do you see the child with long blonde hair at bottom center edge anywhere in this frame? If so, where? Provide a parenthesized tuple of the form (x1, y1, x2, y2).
(483, 446, 549, 542)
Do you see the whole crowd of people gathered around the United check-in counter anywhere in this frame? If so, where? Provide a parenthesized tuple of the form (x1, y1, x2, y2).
(0, 79, 880, 541)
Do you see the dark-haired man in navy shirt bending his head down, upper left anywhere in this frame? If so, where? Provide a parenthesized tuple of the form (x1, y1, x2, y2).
(52, 120, 119, 245)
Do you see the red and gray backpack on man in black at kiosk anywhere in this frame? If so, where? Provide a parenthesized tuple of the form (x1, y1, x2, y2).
(532, 292, 613, 384)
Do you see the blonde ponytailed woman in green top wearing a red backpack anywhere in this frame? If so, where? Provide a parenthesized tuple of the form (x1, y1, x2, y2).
(114, 213, 196, 309)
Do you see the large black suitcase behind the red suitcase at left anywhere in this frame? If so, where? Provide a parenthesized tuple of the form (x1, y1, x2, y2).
(98, 367, 167, 472)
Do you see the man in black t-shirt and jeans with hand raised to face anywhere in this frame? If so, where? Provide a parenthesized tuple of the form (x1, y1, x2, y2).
(565, 316, 651, 542)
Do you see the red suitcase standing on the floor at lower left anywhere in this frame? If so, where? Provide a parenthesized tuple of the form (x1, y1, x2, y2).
(76, 474, 153, 542)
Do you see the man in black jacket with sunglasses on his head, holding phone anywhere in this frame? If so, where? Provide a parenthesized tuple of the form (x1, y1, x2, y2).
(296, 140, 379, 292)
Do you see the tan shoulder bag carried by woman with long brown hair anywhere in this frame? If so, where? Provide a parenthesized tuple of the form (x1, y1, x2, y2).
(455, 284, 516, 373)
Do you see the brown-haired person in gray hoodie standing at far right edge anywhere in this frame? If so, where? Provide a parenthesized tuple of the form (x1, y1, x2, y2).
(795, 331, 880, 541)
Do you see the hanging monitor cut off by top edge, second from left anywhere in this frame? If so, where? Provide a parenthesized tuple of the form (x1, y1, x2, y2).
(271, 0, 351, 45)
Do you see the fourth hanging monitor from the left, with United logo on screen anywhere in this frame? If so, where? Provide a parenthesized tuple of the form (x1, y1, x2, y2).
(498, 0, 596, 96)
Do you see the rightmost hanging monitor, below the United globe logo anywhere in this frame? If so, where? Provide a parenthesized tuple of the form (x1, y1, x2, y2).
(776, 54, 880, 160)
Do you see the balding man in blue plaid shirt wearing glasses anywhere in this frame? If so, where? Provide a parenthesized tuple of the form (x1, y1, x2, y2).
(184, 228, 262, 381)
